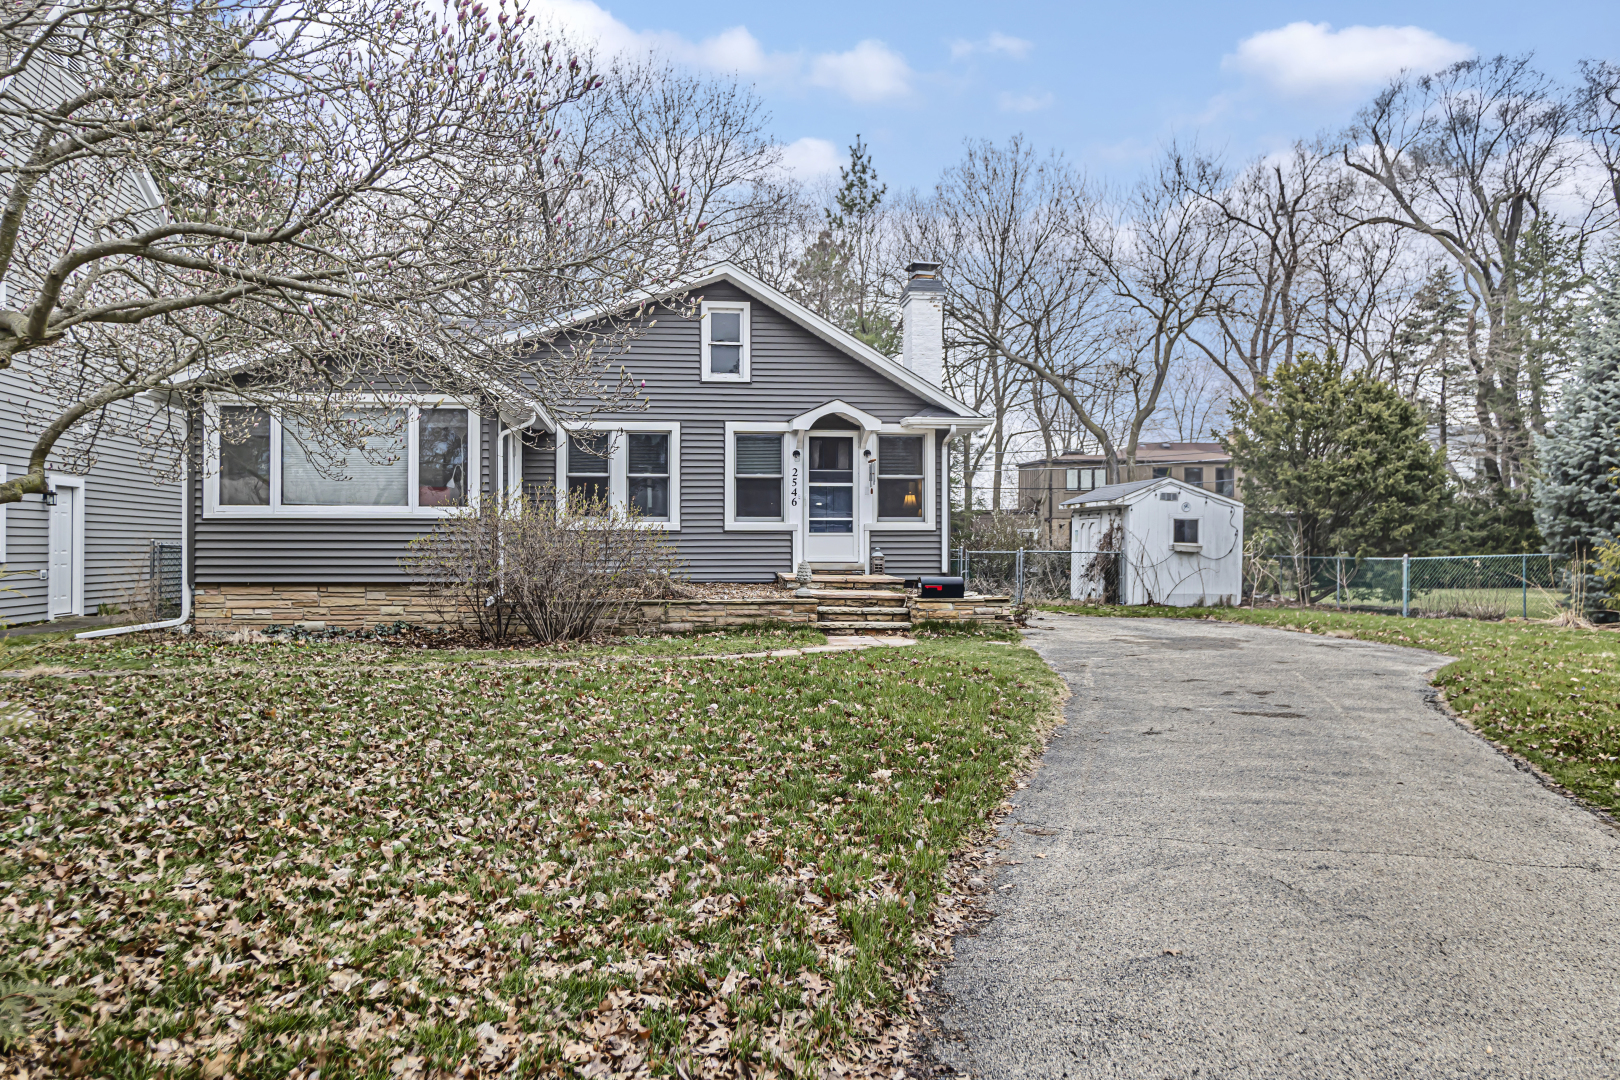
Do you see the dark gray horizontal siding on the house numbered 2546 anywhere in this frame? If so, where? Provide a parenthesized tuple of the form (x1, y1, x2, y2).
(194, 283, 965, 585)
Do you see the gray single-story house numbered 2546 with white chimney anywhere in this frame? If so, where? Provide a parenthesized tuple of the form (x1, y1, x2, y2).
(191, 262, 990, 628)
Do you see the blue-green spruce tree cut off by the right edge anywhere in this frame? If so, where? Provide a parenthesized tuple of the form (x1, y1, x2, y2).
(1534, 256, 1620, 607)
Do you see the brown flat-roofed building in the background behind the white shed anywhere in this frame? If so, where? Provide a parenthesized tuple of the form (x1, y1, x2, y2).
(1017, 442, 1241, 551)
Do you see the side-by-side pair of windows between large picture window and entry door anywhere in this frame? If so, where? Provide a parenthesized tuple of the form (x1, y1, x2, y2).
(559, 423, 680, 528)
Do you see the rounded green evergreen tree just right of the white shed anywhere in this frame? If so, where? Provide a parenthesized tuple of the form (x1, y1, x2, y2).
(1221, 353, 1452, 555)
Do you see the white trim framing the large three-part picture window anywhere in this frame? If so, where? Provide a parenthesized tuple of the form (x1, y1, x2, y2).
(203, 393, 483, 520)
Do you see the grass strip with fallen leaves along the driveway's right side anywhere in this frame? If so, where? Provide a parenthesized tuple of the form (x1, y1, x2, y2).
(1042, 604, 1620, 811)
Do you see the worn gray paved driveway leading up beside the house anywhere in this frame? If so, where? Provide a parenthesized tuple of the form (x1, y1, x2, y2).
(932, 617, 1620, 1080)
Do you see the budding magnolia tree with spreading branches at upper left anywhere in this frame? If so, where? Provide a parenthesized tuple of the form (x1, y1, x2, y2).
(0, 0, 725, 504)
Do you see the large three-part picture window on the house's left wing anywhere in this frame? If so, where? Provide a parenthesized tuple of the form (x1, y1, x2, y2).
(204, 403, 478, 517)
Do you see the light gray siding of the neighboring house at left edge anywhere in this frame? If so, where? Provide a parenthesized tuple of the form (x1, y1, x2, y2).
(0, 372, 181, 625)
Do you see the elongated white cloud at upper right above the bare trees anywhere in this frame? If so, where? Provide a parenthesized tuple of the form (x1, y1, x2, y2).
(1221, 23, 1474, 96)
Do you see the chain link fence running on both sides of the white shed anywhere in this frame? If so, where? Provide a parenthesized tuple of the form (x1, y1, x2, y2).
(951, 547, 1570, 619)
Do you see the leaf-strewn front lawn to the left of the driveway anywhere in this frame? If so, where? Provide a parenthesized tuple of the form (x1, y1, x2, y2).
(0, 635, 1059, 1078)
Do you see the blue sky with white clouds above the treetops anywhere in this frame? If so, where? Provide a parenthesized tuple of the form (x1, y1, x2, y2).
(538, 0, 1620, 189)
